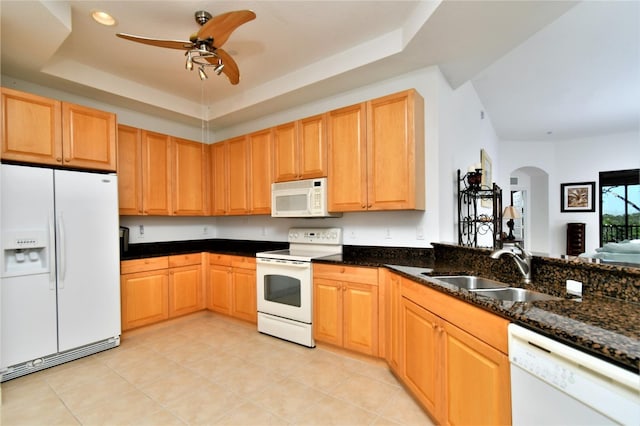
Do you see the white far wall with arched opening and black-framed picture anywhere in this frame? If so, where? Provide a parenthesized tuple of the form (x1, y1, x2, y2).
(500, 132, 640, 256)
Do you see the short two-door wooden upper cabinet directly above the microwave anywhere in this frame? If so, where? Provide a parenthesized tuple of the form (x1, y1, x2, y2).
(274, 114, 327, 182)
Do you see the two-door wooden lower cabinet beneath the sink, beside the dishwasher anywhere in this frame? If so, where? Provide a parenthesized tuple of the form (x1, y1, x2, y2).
(396, 278, 511, 425)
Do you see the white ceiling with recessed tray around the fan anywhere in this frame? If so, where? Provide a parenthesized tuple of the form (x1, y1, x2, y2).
(0, 0, 640, 139)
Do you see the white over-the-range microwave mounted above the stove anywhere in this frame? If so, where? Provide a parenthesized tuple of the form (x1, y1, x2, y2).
(271, 178, 341, 217)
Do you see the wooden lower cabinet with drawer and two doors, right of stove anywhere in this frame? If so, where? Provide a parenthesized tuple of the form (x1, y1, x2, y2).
(313, 264, 379, 356)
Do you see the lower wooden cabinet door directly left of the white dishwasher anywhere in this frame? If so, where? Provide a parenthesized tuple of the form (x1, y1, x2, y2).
(443, 322, 511, 425)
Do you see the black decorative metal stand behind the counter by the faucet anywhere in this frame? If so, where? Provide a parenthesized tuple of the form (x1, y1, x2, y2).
(458, 169, 502, 249)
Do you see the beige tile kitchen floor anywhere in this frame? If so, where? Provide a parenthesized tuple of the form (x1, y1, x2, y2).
(0, 312, 432, 426)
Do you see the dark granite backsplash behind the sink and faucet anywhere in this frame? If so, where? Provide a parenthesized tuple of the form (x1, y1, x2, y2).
(433, 243, 640, 303)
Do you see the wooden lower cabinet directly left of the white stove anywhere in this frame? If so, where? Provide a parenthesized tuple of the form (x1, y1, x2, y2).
(206, 254, 258, 323)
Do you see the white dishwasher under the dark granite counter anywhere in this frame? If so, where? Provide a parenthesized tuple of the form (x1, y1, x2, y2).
(509, 324, 640, 426)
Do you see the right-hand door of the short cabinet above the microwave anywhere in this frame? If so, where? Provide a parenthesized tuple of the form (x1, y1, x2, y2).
(298, 114, 327, 179)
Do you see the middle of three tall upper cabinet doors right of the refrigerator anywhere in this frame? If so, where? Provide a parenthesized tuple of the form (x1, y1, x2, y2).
(142, 130, 172, 216)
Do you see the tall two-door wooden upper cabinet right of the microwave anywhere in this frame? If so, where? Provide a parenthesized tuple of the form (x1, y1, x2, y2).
(327, 90, 425, 212)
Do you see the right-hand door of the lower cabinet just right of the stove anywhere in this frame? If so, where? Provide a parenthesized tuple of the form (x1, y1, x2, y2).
(343, 283, 378, 356)
